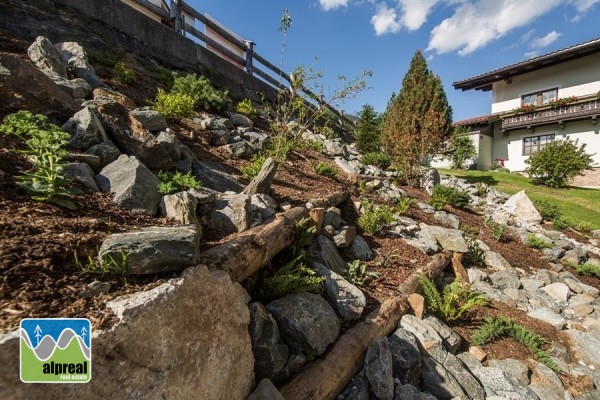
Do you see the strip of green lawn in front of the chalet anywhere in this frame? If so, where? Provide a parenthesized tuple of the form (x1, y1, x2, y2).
(439, 169, 600, 229)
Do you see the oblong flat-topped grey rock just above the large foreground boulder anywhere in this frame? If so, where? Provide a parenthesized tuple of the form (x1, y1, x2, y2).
(98, 225, 200, 274)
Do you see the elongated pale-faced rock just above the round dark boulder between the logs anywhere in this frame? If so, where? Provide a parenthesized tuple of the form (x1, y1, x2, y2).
(314, 263, 367, 321)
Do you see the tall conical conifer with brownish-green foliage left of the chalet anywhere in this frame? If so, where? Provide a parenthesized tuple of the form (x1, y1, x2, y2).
(382, 51, 452, 186)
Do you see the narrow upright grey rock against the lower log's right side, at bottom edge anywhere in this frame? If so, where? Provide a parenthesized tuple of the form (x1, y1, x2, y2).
(365, 336, 394, 400)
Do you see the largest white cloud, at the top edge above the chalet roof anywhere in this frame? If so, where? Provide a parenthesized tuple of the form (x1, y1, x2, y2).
(427, 0, 562, 55)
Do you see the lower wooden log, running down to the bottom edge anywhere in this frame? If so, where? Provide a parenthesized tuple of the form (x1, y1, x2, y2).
(281, 252, 450, 400)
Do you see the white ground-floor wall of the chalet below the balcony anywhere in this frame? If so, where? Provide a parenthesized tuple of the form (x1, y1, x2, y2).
(492, 119, 600, 171)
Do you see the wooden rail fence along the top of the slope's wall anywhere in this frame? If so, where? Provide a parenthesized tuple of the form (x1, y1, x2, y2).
(120, 0, 351, 123)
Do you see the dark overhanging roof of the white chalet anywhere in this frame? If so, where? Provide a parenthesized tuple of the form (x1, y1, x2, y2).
(452, 38, 600, 92)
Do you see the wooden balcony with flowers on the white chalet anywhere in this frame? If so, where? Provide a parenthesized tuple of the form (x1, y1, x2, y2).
(501, 98, 600, 133)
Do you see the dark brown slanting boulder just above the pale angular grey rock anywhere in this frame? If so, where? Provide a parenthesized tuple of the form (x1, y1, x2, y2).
(98, 103, 173, 169)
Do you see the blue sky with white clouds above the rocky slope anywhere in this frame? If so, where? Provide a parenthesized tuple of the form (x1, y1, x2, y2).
(188, 0, 600, 121)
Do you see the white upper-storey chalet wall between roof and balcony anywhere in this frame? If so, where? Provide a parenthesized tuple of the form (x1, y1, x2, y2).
(492, 54, 600, 114)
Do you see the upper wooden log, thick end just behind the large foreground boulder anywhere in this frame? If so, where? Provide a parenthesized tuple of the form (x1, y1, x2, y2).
(198, 207, 308, 282)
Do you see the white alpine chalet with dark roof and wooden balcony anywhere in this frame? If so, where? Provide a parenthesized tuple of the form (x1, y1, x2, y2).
(453, 38, 600, 181)
